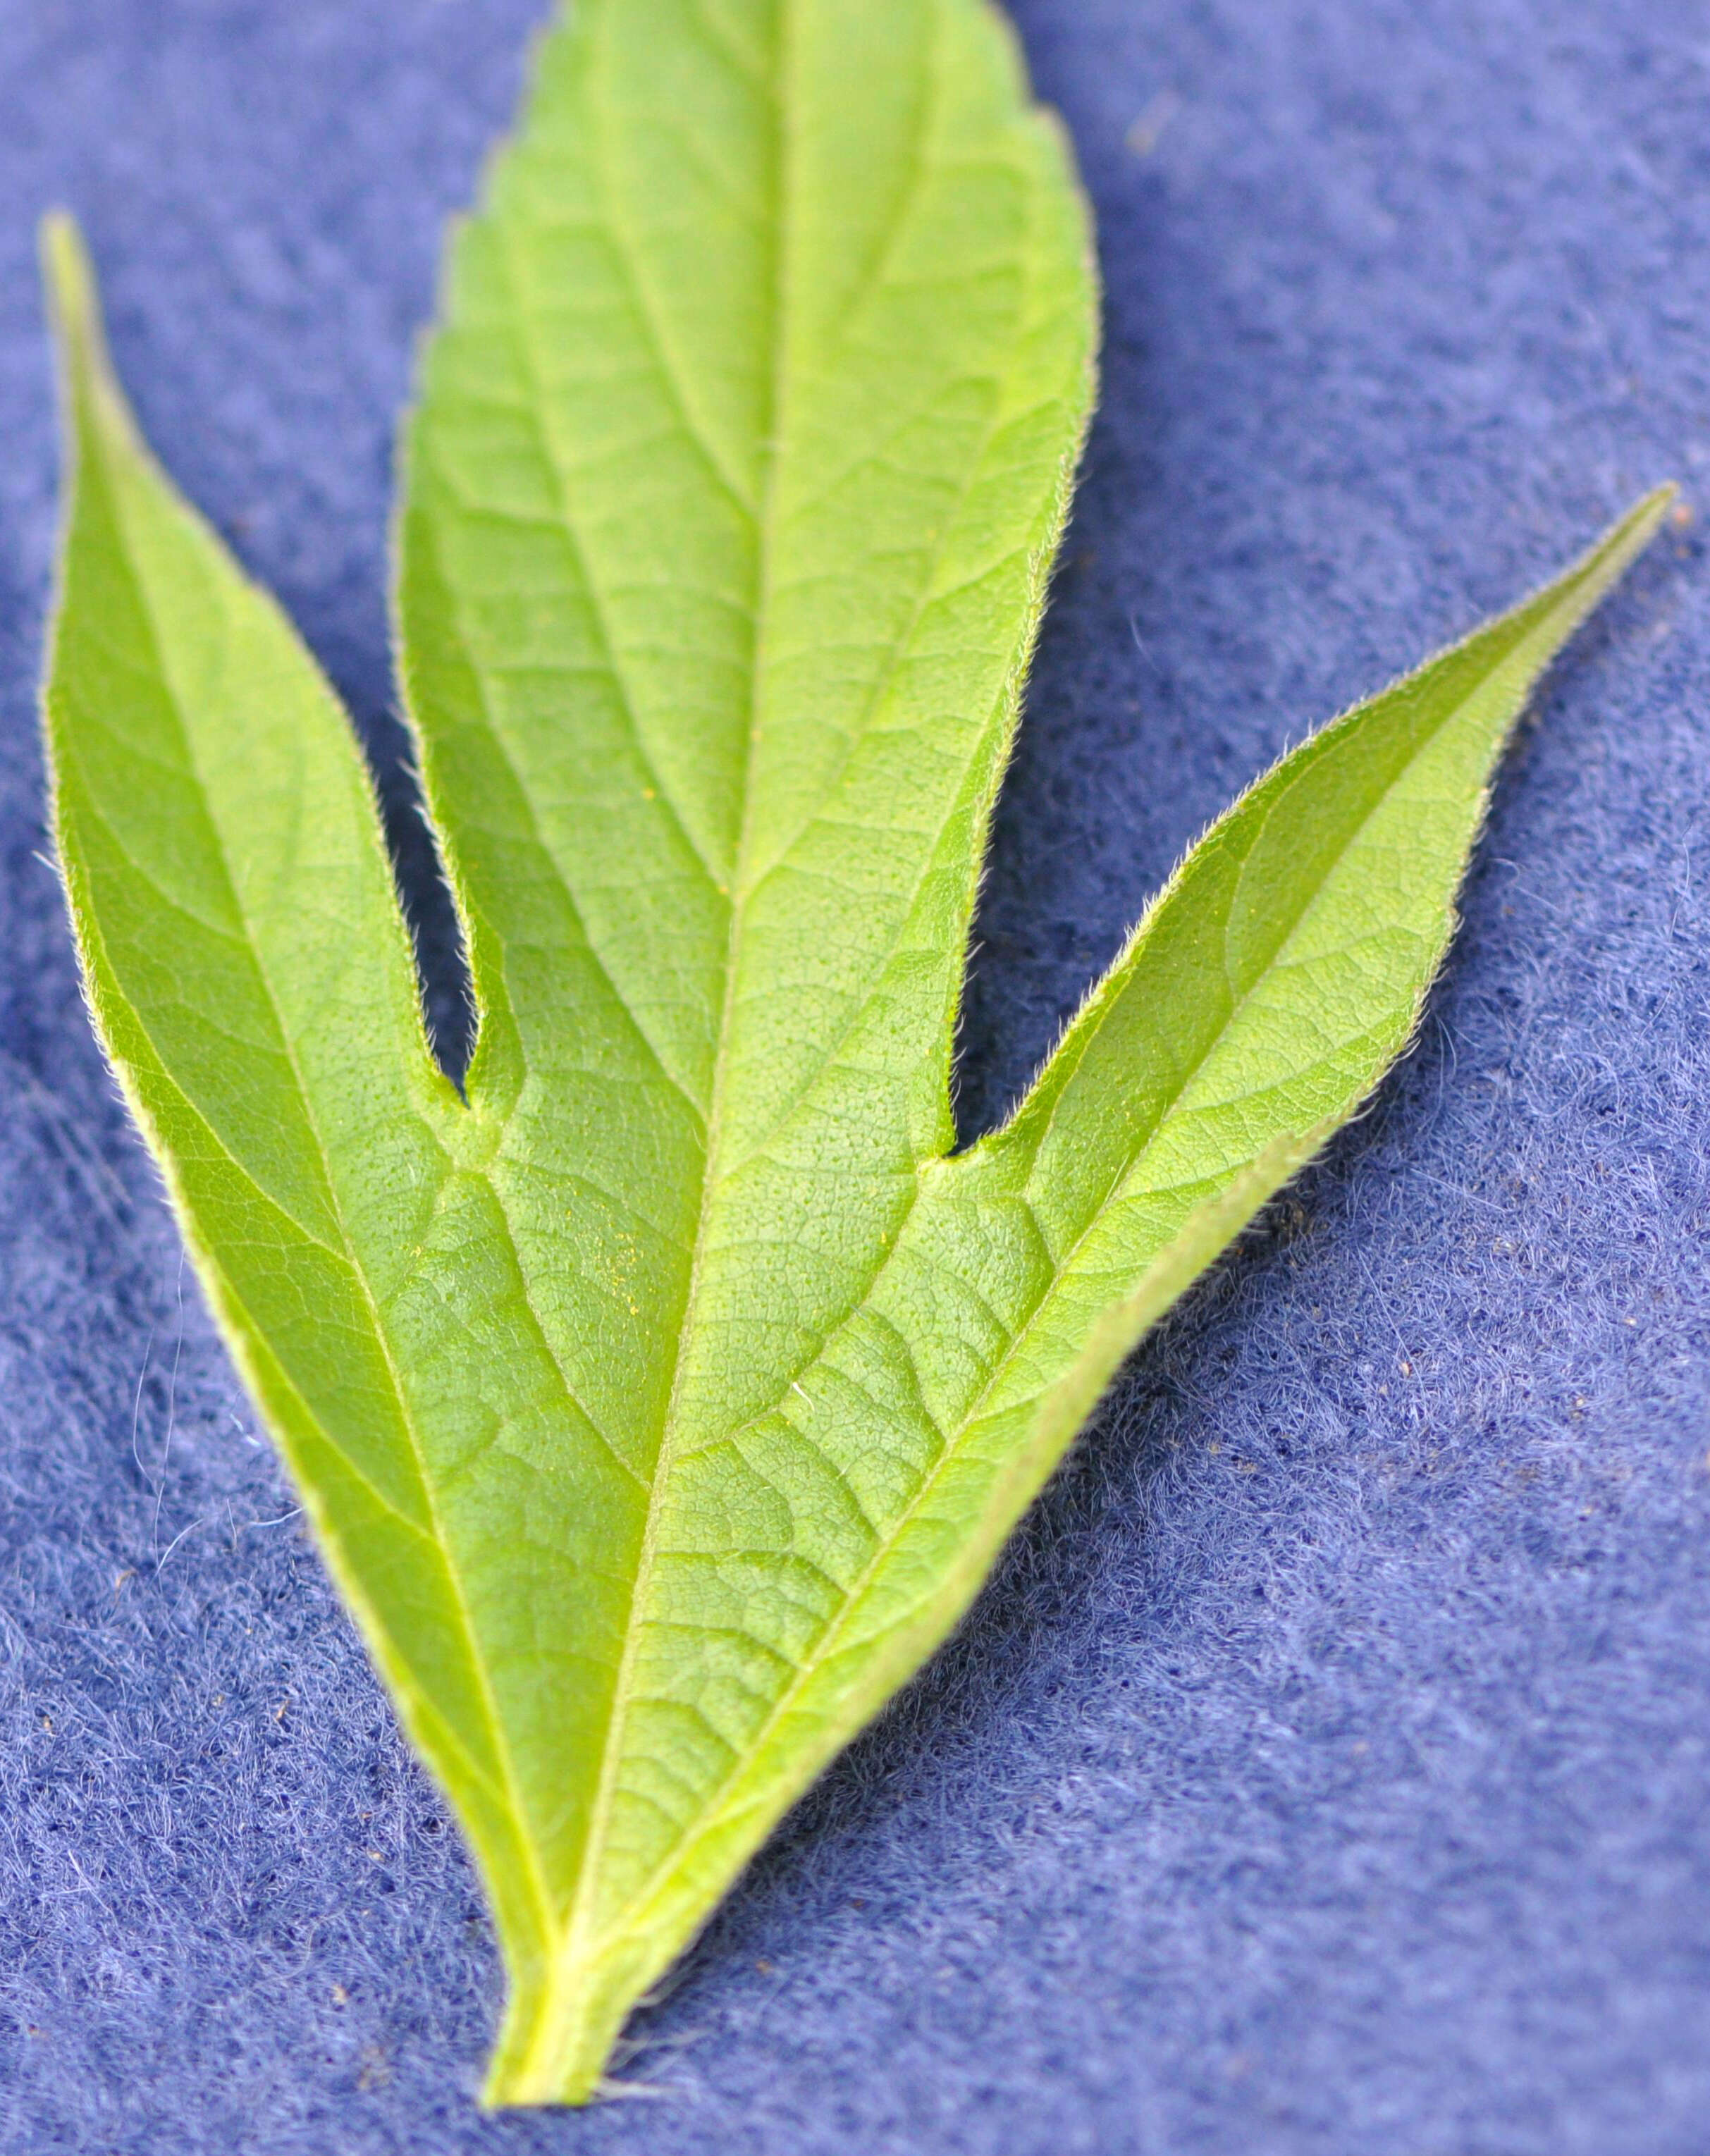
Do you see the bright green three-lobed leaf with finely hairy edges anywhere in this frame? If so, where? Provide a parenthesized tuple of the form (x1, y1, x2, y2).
(47, 0, 1667, 2102)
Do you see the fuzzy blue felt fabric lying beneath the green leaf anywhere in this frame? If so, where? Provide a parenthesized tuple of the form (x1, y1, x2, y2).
(0, 0, 1710, 2156)
